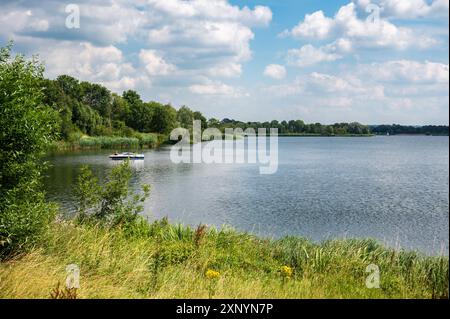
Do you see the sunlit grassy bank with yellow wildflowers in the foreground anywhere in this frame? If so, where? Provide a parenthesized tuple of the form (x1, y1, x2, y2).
(0, 221, 449, 298)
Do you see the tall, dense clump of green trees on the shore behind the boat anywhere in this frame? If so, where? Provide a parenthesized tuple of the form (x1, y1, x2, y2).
(45, 75, 183, 145)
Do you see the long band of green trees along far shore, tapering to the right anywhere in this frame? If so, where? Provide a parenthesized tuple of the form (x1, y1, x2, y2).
(43, 75, 370, 141)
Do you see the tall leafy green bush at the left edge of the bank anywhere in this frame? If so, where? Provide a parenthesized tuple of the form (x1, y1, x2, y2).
(0, 45, 59, 257)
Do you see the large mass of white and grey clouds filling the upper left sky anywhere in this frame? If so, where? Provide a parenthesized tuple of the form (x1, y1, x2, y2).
(0, 0, 272, 97)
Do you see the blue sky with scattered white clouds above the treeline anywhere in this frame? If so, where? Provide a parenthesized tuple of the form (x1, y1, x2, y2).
(0, 0, 449, 125)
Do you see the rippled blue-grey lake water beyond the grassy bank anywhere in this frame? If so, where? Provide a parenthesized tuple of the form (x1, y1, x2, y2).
(45, 136, 449, 255)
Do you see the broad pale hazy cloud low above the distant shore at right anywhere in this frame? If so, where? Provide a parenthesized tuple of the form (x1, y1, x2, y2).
(260, 60, 448, 124)
